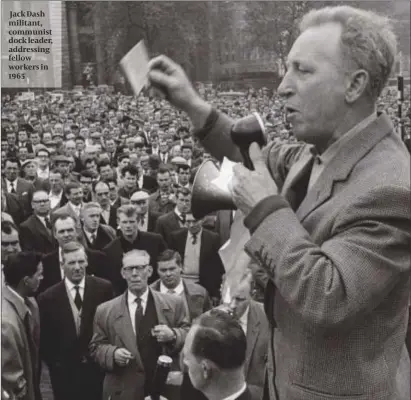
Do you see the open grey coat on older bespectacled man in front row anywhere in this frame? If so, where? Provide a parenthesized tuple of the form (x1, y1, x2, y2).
(90, 290, 189, 400)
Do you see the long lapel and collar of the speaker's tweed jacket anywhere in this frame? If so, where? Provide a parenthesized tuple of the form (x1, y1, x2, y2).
(296, 114, 393, 221)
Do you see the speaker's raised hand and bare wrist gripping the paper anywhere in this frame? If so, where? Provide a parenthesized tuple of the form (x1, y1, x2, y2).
(148, 56, 211, 129)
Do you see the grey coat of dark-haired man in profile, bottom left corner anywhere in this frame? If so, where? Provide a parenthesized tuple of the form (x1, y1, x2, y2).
(1, 286, 41, 400)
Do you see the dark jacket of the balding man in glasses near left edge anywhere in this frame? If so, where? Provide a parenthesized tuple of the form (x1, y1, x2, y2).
(20, 214, 58, 254)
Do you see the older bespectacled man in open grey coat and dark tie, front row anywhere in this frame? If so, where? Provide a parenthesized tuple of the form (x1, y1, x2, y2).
(90, 250, 189, 400)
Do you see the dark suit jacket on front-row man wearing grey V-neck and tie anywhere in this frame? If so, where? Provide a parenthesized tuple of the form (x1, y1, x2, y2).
(38, 276, 113, 399)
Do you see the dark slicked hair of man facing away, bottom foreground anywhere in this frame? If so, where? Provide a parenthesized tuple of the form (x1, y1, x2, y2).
(191, 309, 247, 370)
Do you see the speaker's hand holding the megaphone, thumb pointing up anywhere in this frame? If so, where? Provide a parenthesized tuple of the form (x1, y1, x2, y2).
(231, 143, 278, 215)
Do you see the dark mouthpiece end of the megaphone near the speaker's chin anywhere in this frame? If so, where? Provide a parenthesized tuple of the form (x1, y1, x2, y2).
(231, 113, 267, 171)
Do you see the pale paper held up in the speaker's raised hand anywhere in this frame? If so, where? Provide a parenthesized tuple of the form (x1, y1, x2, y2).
(120, 40, 149, 96)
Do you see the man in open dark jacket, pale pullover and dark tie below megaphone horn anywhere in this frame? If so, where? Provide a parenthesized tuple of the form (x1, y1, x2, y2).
(170, 213, 225, 304)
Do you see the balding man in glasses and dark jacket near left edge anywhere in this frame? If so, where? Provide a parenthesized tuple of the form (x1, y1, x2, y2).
(20, 190, 58, 255)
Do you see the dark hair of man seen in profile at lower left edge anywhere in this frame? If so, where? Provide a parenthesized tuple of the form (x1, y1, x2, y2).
(3, 251, 42, 288)
